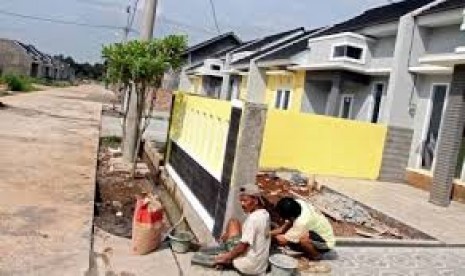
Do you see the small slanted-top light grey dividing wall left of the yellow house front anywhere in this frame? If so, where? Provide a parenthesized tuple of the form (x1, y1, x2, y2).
(246, 61, 266, 104)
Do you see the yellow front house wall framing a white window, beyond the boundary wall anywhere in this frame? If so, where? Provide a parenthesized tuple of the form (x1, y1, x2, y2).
(265, 71, 305, 112)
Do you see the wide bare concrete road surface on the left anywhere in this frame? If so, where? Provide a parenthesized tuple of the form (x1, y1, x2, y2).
(0, 86, 108, 275)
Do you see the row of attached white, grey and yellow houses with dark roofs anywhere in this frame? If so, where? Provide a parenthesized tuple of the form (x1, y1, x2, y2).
(174, 0, 465, 206)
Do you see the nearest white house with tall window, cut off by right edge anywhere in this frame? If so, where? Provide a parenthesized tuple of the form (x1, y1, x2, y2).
(396, 0, 465, 206)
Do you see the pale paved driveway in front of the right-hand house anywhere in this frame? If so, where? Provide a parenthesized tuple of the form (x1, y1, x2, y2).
(317, 176, 465, 245)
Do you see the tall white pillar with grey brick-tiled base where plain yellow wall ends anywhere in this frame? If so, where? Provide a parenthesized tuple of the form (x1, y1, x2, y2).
(379, 14, 424, 182)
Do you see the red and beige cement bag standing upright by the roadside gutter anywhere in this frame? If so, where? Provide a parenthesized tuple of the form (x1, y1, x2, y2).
(132, 192, 163, 255)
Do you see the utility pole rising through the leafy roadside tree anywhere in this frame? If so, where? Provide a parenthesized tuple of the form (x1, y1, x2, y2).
(123, 0, 158, 162)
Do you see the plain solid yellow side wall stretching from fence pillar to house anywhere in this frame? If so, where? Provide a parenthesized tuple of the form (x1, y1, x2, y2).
(260, 110, 387, 179)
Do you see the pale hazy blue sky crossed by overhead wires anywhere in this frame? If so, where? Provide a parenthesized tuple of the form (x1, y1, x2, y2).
(0, 0, 389, 62)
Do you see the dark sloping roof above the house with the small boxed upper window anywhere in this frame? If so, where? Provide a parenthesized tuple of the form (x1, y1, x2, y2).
(321, 0, 436, 35)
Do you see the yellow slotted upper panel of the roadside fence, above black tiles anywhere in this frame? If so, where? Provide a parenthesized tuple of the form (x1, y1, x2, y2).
(170, 93, 232, 176)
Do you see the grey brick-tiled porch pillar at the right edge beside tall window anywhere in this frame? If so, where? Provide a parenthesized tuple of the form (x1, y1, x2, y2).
(430, 64, 465, 207)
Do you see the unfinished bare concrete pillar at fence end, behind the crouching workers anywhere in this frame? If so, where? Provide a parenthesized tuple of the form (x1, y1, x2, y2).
(219, 103, 267, 233)
